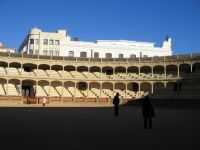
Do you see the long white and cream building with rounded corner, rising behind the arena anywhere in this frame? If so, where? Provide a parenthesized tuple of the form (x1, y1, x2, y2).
(19, 28, 172, 58)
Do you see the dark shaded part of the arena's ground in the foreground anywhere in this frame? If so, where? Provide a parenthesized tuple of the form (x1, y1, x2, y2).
(0, 106, 200, 150)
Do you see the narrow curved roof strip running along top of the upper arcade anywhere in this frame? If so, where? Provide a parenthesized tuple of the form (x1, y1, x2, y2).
(0, 52, 200, 62)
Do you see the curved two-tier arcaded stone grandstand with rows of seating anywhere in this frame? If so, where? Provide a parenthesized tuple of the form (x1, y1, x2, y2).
(0, 53, 200, 103)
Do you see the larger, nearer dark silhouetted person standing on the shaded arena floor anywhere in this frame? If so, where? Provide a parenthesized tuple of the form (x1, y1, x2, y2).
(142, 96, 155, 129)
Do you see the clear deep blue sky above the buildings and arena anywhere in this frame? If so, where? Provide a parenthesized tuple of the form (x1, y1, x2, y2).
(0, 0, 200, 54)
